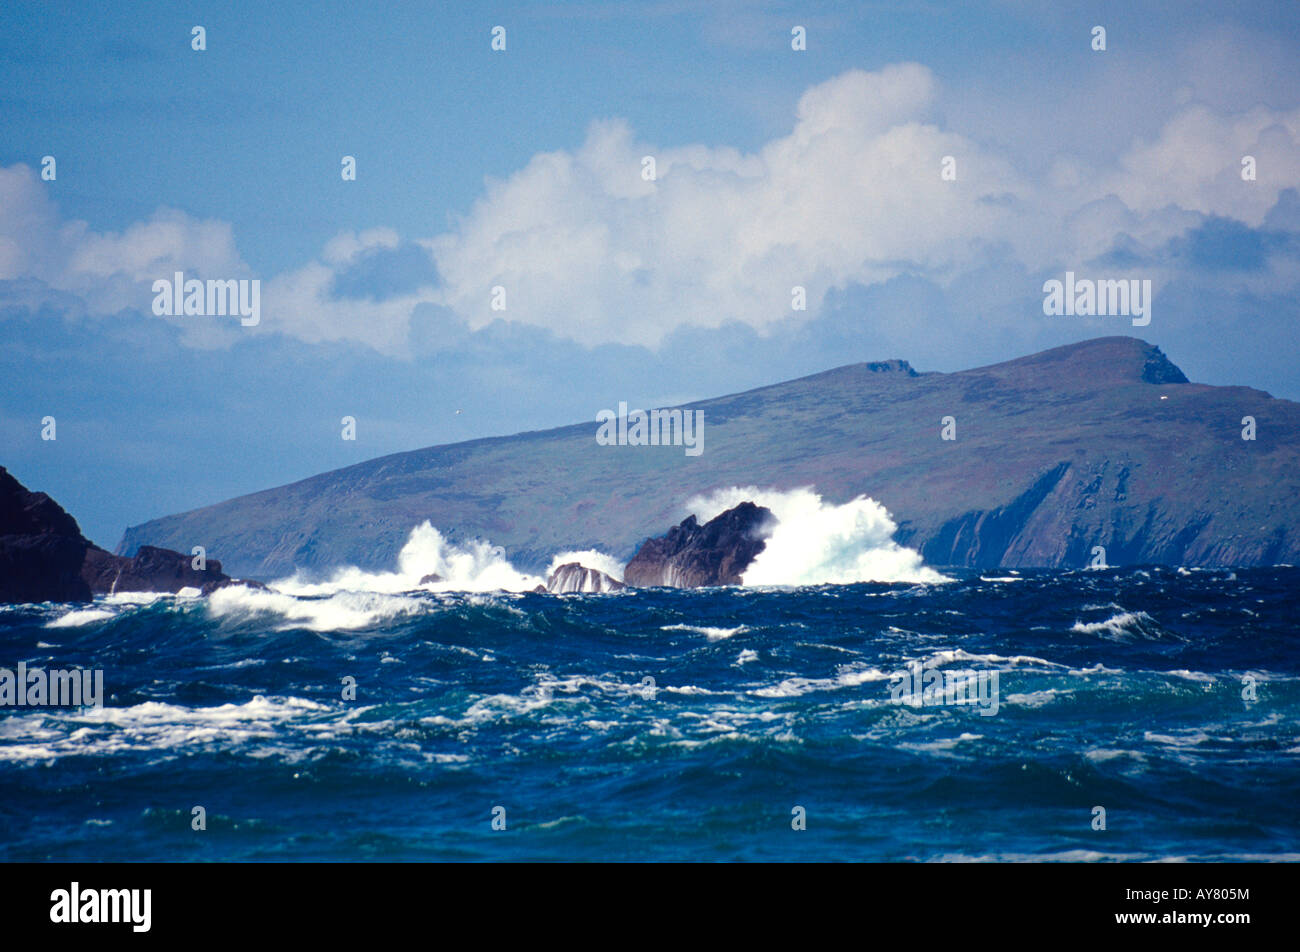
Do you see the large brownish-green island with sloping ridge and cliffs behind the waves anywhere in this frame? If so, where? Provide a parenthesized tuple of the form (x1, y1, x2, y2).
(118, 337, 1300, 577)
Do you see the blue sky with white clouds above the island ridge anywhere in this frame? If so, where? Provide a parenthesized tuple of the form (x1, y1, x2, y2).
(0, 0, 1300, 548)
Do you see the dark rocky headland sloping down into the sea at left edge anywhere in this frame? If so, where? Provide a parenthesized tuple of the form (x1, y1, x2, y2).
(0, 467, 253, 603)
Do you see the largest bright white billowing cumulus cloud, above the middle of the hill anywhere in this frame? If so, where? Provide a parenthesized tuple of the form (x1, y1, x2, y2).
(430, 64, 1023, 346)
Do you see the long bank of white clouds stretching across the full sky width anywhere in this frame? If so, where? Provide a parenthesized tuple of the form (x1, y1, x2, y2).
(0, 64, 1300, 355)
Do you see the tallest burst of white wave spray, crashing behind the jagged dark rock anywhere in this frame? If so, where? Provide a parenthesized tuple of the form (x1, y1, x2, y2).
(686, 486, 952, 585)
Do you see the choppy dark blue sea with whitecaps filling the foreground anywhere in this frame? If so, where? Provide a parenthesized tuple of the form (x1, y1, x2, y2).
(0, 568, 1300, 860)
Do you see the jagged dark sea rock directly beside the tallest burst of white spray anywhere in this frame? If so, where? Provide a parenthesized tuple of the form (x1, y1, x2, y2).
(623, 502, 776, 588)
